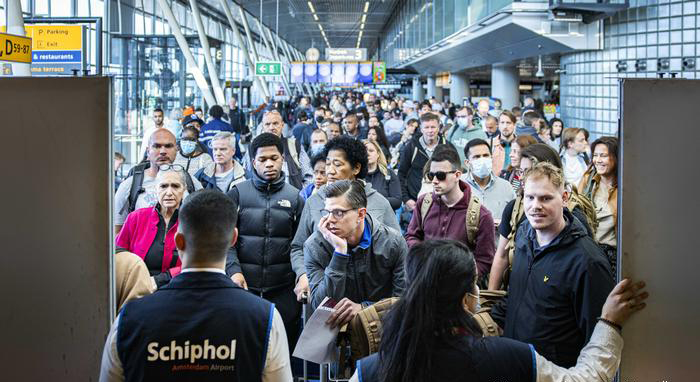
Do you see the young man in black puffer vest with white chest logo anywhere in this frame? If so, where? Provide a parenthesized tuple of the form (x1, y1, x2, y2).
(227, 133, 306, 349)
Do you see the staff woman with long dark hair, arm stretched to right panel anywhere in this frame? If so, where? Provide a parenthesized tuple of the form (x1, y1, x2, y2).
(351, 240, 648, 382)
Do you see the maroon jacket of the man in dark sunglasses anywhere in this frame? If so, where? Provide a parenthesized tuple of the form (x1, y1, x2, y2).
(406, 181, 496, 276)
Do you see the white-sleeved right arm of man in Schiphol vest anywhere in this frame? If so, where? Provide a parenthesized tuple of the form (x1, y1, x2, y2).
(262, 308, 292, 382)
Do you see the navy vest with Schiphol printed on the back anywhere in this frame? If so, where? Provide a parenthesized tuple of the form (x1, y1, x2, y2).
(117, 272, 274, 381)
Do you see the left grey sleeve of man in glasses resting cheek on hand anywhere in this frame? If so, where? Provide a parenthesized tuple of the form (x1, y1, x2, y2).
(304, 241, 350, 310)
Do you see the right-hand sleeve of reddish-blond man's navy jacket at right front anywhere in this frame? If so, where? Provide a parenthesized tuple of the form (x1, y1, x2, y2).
(573, 254, 615, 341)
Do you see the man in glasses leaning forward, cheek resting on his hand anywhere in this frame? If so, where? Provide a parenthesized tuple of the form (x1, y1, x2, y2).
(304, 180, 408, 327)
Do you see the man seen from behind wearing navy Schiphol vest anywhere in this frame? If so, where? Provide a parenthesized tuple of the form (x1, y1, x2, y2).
(100, 190, 292, 382)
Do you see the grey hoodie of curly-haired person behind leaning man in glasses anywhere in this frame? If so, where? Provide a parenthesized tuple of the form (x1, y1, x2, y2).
(290, 183, 401, 282)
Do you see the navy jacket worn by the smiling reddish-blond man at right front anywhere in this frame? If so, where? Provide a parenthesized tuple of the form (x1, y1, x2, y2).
(491, 209, 615, 367)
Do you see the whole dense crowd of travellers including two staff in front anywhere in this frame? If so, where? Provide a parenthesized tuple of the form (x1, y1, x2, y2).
(100, 91, 648, 382)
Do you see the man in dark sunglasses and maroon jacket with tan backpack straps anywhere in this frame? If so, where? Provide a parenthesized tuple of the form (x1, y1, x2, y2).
(406, 146, 496, 287)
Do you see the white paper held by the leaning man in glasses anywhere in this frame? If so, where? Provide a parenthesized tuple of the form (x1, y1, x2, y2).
(292, 297, 339, 364)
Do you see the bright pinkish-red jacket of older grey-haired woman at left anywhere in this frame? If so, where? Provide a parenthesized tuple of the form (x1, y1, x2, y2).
(116, 207, 182, 277)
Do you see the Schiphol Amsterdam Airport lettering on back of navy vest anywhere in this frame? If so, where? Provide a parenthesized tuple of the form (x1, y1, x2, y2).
(146, 339, 236, 371)
